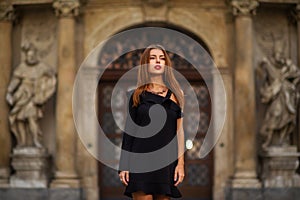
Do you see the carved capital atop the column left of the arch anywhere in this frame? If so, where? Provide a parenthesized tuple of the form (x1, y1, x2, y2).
(53, 0, 80, 17)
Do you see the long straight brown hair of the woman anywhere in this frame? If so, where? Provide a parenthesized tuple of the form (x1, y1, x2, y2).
(133, 44, 184, 108)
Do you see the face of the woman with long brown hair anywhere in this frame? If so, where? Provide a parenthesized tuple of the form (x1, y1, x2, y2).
(148, 49, 166, 75)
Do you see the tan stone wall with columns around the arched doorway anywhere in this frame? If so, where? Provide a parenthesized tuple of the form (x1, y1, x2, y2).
(0, 0, 300, 200)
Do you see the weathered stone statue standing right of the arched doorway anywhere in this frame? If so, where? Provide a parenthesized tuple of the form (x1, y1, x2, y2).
(259, 43, 300, 149)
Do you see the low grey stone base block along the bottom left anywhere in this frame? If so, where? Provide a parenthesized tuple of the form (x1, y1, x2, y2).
(0, 188, 85, 200)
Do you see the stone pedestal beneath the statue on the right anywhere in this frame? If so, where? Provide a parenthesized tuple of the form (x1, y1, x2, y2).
(260, 146, 300, 188)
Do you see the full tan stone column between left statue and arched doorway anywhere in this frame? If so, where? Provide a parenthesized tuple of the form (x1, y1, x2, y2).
(51, 0, 80, 187)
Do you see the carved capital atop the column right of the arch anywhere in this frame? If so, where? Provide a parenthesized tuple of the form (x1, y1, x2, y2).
(231, 0, 258, 16)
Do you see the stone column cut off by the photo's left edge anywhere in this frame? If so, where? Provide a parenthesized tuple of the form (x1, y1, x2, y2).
(0, 3, 14, 187)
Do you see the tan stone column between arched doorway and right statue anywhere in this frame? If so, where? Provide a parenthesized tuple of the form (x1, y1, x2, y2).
(231, 0, 261, 188)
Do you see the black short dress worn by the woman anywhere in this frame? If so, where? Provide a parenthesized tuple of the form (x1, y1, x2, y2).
(119, 90, 183, 198)
